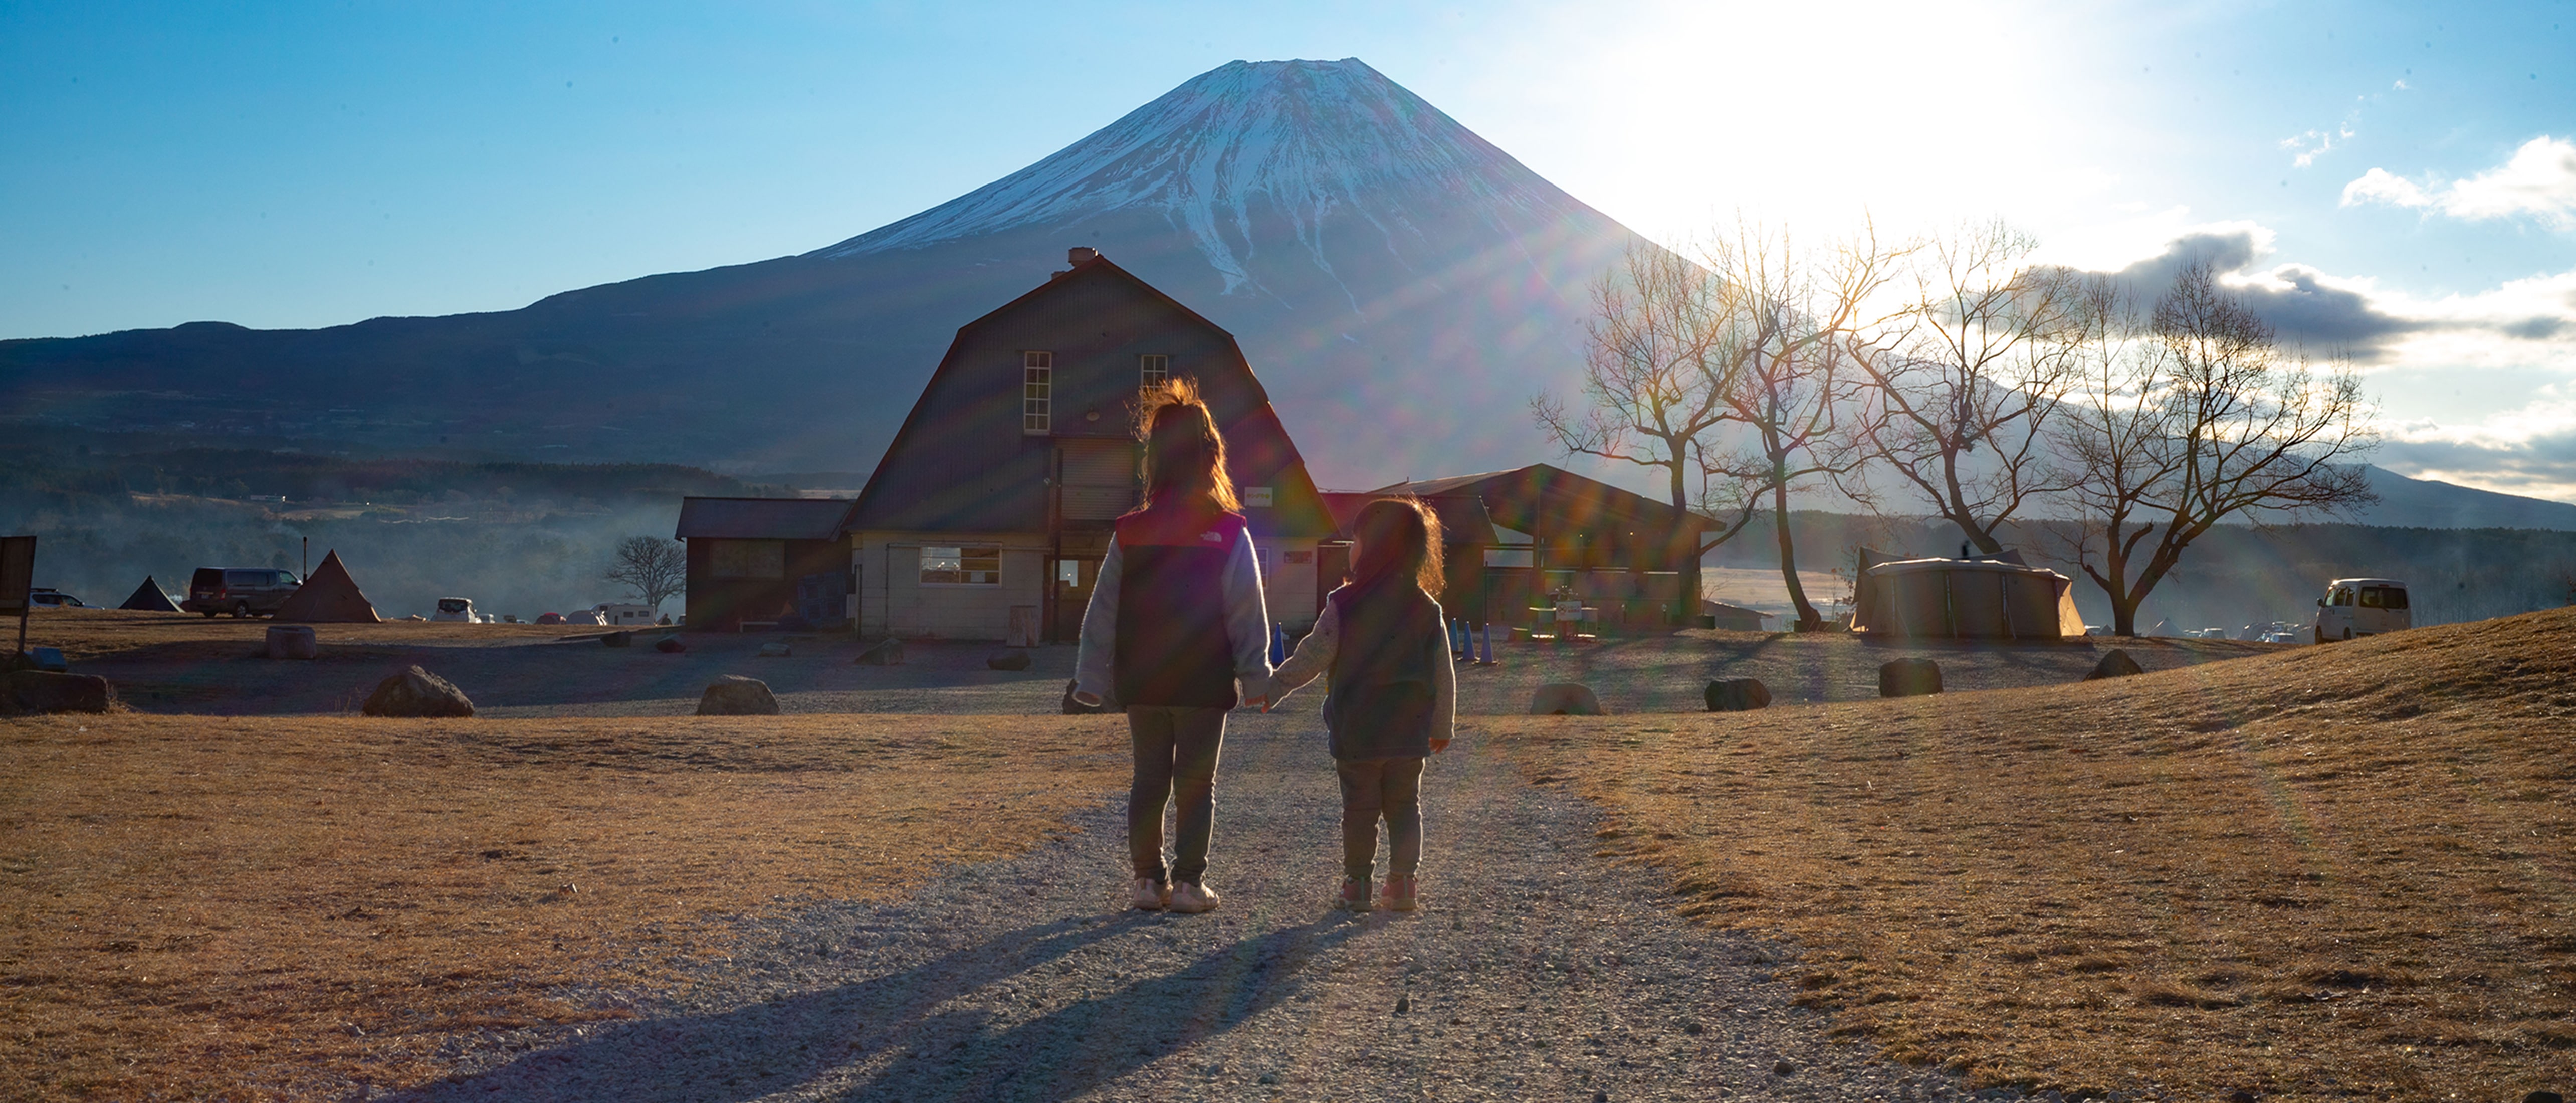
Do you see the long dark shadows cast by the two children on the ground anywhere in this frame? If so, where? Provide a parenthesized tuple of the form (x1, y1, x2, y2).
(391, 912, 1365, 1103)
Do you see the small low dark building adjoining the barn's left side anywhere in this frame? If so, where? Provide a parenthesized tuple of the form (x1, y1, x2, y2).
(675, 497, 850, 631)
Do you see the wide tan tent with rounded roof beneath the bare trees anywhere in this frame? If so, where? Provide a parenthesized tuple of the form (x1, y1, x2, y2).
(1852, 559, 2084, 639)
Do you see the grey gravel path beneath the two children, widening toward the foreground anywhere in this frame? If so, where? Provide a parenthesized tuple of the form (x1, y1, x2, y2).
(386, 714, 2009, 1100)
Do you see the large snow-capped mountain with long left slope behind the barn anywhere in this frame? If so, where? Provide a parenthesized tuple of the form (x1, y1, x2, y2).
(0, 59, 1641, 487)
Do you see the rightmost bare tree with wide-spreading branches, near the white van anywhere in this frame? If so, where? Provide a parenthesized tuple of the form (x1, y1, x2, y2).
(2056, 265, 2378, 637)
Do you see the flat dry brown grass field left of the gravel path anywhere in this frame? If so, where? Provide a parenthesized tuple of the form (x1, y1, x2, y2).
(0, 711, 1128, 1100)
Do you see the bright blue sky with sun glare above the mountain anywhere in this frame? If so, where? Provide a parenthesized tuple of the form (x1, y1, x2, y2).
(15, 3, 2576, 500)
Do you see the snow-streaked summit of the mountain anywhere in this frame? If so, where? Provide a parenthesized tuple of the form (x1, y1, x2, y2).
(819, 57, 1600, 294)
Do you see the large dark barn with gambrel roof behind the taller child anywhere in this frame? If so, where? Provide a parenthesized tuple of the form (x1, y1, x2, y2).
(840, 247, 1335, 644)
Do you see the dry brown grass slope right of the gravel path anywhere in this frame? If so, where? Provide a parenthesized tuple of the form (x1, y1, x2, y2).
(1478, 611, 2576, 1100)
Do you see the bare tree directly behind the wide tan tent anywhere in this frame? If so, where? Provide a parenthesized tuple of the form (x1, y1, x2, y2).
(1839, 222, 2097, 554)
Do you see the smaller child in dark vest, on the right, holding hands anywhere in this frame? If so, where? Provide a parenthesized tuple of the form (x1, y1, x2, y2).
(1272, 497, 1458, 912)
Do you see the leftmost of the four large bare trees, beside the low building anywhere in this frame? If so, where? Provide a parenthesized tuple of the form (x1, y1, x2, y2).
(1530, 242, 1760, 616)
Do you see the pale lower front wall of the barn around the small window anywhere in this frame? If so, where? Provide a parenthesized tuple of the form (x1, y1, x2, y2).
(850, 533, 1046, 639)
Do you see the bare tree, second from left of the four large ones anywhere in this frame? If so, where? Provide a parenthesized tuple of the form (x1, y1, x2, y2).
(1703, 227, 1903, 631)
